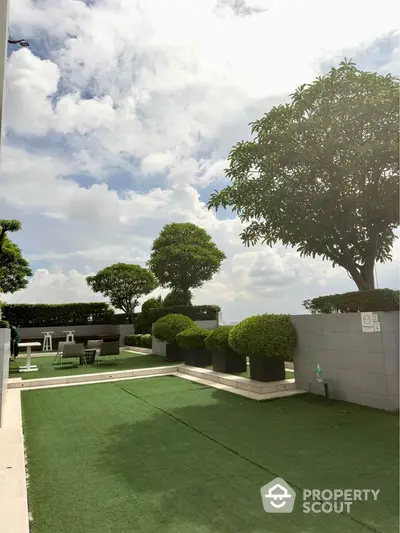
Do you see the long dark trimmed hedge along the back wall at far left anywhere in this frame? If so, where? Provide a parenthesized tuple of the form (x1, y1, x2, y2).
(2, 302, 114, 328)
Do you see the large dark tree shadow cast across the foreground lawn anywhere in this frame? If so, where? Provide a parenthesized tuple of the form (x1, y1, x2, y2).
(95, 377, 398, 533)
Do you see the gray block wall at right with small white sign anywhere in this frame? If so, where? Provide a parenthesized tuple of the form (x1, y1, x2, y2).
(292, 312, 399, 411)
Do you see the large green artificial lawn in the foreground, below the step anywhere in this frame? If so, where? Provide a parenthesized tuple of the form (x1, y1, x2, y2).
(22, 377, 398, 533)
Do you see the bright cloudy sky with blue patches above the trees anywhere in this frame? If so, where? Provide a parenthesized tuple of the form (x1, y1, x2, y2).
(0, 0, 400, 322)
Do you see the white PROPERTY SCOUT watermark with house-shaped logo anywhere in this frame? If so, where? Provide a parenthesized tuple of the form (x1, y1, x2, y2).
(261, 477, 380, 514)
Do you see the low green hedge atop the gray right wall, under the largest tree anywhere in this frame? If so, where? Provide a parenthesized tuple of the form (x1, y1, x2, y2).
(303, 289, 400, 314)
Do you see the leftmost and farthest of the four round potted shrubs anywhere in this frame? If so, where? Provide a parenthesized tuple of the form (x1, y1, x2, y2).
(153, 314, 196, 362)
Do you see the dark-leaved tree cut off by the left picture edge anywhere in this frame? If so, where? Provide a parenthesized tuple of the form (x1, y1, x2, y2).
(0, 220, 32, 293)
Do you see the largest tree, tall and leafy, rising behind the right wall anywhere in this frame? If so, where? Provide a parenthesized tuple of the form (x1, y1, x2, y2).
(208, 61, 399, 290)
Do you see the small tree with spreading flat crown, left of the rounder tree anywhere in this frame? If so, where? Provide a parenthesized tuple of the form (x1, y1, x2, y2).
(86, 263, 157, 317)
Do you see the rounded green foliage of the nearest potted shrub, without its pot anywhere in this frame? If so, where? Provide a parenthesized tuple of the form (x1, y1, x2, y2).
(229, 314, 296, 360)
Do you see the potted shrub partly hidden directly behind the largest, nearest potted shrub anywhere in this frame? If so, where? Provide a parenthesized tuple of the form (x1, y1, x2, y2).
(205, 326, 247, 374)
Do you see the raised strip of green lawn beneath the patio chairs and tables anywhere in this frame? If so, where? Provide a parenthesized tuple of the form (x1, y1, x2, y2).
(9, 351, 176, 379)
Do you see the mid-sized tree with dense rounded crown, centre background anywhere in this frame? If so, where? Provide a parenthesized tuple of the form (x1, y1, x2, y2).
(148, 222, 225, 305)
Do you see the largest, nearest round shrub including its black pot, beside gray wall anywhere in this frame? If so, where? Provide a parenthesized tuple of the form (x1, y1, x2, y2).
(229, 314, 296, 381)
